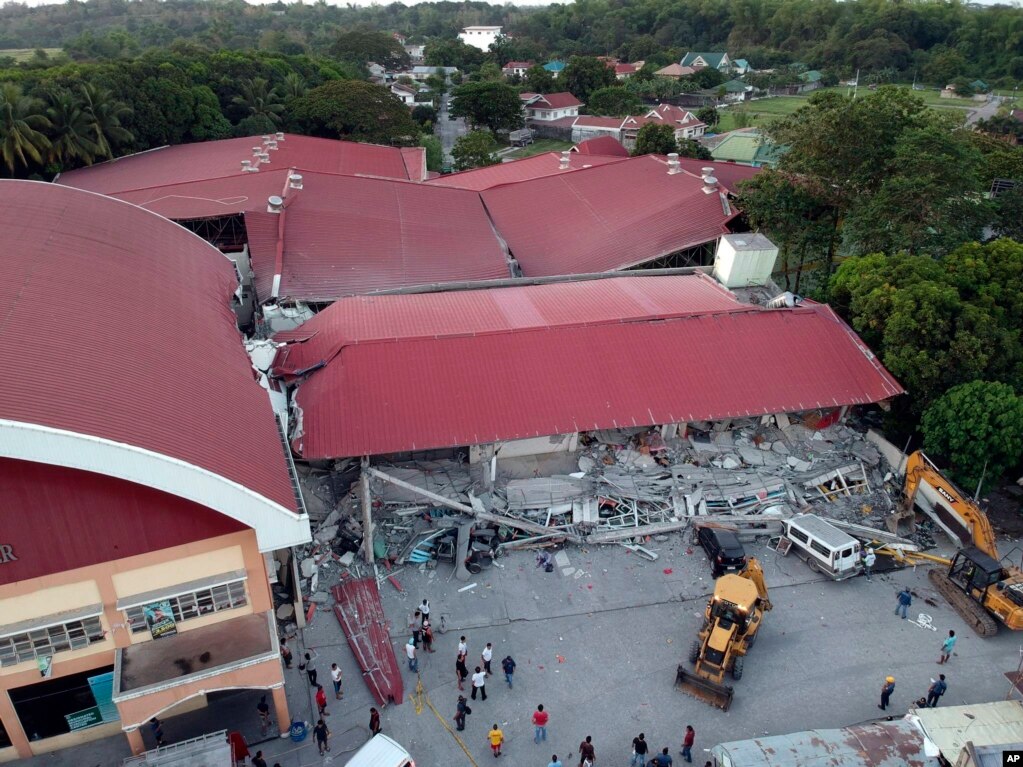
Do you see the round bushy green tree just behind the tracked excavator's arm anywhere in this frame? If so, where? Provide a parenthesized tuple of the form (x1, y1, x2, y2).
(921, 380, 1023, 492)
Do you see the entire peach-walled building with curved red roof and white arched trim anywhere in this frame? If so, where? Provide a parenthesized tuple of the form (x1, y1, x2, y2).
(0, 180, 310, 762)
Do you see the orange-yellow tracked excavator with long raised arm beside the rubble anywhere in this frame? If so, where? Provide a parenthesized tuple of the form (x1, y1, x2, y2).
(903, 450, 1023, 637)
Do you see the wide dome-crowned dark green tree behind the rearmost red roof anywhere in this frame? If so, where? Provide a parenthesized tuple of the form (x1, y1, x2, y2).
(288, 80, 419, 146)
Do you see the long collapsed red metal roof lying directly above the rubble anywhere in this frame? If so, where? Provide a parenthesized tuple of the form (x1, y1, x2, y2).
(278, 276, 902, 459)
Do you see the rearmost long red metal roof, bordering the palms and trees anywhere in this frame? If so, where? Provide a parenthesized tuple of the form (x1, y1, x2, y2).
(57, 134, 426, 195)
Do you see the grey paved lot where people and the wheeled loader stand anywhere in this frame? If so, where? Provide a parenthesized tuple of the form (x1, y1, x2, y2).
(255, 534, 1019, 767)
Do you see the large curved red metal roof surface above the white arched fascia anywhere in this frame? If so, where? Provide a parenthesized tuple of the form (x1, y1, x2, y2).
(0, 181, 296, 510)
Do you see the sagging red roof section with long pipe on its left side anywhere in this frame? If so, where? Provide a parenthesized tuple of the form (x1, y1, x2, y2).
(246, 173, 510, 302)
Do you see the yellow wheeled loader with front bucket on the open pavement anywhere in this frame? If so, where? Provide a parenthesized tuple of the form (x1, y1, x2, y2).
(675, 557, 771, 711)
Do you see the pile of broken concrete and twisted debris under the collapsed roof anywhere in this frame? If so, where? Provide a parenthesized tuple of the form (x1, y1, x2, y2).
(280, 415, 934, 617)
